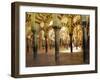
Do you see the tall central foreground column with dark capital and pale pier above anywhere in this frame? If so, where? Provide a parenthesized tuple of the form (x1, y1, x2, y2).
(53, 14, 61, 64)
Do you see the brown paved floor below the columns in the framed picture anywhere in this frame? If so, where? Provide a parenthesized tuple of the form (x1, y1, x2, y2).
(26, 52, 83, 67)
